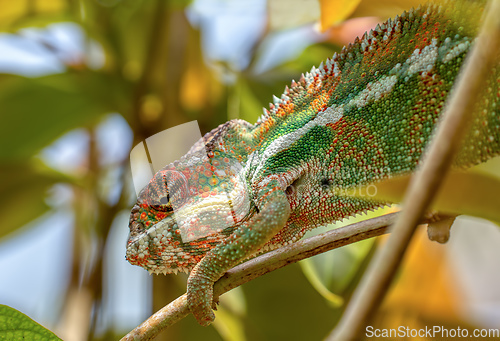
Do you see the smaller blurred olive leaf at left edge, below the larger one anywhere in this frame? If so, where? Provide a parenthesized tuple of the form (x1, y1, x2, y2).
(0, 162, 67, 238)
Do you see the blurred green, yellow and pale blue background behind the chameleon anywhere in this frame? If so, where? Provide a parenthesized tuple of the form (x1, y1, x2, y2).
(0, 0, 500, 340)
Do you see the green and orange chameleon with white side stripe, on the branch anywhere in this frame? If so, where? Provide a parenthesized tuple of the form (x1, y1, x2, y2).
(127, 2, 500, 325)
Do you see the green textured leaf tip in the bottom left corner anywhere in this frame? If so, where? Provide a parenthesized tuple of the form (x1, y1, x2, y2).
(0, 304, 61, 341)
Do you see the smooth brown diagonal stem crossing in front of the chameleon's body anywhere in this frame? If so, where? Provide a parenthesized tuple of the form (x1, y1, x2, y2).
(328, 0, 500, 341)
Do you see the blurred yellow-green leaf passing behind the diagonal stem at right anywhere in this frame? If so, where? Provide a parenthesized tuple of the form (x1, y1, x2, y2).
(342, 171, 500, 224)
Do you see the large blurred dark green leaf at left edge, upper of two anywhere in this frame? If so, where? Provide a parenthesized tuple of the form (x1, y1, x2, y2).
(0, 71, 123, 162)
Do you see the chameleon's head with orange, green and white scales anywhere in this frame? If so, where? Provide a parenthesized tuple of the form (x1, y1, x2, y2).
(126, 158, 250, 274)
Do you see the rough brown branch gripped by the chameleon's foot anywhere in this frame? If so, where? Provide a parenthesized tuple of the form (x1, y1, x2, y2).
(122, 213, 435, 340)
